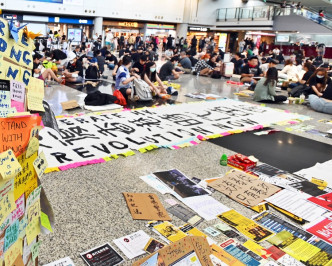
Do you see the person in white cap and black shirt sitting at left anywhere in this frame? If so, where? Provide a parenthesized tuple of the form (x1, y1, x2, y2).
(63, 52, 83, 83)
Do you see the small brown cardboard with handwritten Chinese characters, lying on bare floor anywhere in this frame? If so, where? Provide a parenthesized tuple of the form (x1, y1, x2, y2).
(123, 192, 172, 221)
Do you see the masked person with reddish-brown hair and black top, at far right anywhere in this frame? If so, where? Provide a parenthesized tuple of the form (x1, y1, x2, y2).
(307, 68, 331, 97)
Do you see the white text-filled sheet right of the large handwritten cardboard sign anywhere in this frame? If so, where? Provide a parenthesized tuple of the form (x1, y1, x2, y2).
(265, 189, 326, 222)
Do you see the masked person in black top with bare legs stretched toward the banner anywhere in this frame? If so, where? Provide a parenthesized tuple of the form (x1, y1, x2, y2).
(141, 62, 167, 98)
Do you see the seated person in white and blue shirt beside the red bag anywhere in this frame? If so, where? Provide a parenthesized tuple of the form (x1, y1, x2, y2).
(115, 56, 140, 101)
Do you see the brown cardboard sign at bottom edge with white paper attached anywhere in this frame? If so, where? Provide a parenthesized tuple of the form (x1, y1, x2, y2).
(133, 236, 213, 266)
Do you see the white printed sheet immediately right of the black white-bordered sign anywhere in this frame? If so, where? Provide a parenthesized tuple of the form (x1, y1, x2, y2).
(113, 230, 150, 260)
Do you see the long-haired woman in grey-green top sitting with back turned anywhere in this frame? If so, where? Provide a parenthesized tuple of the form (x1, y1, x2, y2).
(254, 67, 287, 103)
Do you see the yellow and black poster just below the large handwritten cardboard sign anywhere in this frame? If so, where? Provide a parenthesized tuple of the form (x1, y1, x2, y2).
(218, 210, 274, 242)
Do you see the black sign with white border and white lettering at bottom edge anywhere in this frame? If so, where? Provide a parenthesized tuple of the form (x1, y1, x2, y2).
(80, 243, 123, 266)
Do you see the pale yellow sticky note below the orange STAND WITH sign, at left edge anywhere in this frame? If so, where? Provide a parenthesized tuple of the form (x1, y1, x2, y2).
(0, 150, 22, 179)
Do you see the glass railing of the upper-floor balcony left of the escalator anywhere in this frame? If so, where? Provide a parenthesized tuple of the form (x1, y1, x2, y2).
(217, 6, 275, 21)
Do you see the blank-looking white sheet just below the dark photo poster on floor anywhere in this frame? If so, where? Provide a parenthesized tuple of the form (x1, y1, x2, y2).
(181, 195, 230, 221)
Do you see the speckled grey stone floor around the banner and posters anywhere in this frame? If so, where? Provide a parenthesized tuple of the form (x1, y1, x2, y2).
(39, 75, 332, 266)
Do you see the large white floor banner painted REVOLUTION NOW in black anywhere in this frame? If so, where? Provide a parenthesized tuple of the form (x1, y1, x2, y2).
(40, 99, 304, 170)
